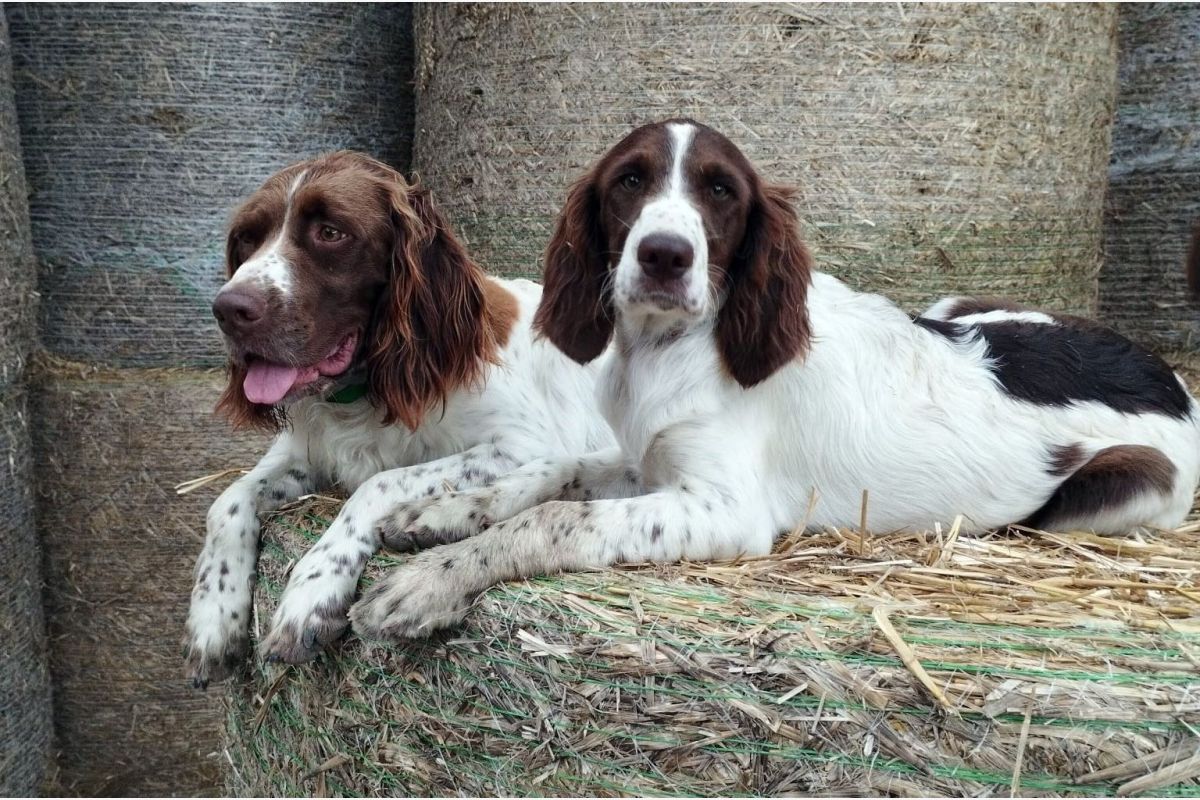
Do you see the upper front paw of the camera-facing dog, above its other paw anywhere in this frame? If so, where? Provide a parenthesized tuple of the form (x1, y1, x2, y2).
(379, 492, 492, 552)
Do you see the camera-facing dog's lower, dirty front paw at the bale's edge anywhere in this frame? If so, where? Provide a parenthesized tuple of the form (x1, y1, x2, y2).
(350, 551, 479, 640)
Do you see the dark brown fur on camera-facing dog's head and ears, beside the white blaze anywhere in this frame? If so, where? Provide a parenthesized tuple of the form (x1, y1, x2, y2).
(534, 120, 811, 386)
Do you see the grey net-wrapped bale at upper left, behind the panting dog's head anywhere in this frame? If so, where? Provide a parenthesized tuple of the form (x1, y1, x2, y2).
(7, 4, 413, 366)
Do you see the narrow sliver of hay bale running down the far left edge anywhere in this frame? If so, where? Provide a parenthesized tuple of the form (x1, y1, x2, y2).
(0, 14, 52, 796)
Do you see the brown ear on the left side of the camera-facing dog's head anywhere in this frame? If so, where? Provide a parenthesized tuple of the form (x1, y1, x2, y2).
(533, 175, 613, 363)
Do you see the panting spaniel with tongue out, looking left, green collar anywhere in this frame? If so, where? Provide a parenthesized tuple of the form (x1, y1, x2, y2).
(187, 152, 612, 687)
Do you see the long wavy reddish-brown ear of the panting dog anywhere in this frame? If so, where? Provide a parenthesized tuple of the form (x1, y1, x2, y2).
(366, 182, 498, 431)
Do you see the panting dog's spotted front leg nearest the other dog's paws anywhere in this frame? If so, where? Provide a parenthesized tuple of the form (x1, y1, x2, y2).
(259, 445, 515, 663)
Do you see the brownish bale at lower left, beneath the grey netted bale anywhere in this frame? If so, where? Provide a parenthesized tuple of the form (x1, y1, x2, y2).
(31, 357, 265, 795)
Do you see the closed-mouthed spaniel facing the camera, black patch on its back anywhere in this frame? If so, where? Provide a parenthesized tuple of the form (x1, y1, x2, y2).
(350, 120, 1200, 638)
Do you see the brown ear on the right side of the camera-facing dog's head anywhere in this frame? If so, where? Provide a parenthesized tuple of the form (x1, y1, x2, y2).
(716, 186, 812, 389)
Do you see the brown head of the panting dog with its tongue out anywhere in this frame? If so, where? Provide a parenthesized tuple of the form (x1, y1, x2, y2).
(212, 152, 506, 428)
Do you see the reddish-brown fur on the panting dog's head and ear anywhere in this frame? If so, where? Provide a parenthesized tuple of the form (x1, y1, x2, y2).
(217, 152, 499, 428)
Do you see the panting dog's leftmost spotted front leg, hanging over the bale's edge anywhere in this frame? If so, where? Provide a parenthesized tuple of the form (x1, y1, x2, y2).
(185, 435, 312, 688)
